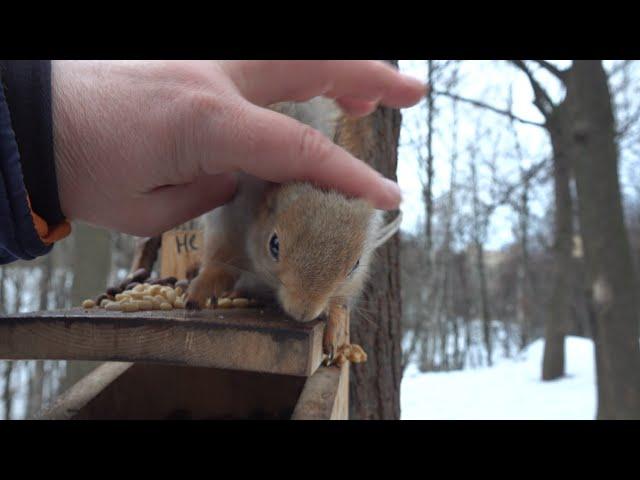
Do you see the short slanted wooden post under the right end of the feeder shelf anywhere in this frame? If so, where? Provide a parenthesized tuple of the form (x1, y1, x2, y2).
(291, 362, 349, 420)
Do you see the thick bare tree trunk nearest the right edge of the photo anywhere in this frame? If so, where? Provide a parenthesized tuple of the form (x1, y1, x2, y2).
(566, 60, 640, 419)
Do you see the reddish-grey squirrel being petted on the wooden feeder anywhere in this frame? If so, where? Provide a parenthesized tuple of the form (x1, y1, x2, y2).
(186, 97, 402, 359)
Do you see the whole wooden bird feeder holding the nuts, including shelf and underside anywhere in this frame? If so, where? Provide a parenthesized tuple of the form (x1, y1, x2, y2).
(0, 232, 349, 420)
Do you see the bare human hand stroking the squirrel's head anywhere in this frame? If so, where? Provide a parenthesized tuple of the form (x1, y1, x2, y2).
(52, 61, 425, 236)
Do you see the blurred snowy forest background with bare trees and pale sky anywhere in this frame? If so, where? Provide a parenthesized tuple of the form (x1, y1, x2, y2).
(0, 60, 640, 419)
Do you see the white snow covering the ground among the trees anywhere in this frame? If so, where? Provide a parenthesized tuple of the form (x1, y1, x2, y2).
(400, 337, 596, 420)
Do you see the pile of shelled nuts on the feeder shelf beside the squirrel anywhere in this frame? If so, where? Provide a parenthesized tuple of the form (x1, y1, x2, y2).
(82, 268, 257, 312)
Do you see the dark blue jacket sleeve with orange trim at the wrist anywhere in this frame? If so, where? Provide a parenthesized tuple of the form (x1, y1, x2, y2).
(0, 61, 64, 264)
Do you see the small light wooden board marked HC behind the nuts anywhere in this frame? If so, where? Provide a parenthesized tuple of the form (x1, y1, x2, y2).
(160, 230, 204, 279)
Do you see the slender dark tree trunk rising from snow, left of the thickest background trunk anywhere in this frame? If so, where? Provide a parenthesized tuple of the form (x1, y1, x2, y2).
(542, 105, 573, 380)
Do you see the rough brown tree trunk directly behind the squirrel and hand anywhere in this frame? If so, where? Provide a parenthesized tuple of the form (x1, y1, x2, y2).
(335, 64, 402, 420)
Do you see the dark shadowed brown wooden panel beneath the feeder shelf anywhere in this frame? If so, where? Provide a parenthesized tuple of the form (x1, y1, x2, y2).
(60, 363, 306, 420)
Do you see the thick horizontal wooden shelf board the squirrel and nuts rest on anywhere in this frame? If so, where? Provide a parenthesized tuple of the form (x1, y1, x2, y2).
(0, 309, 324, 376)
